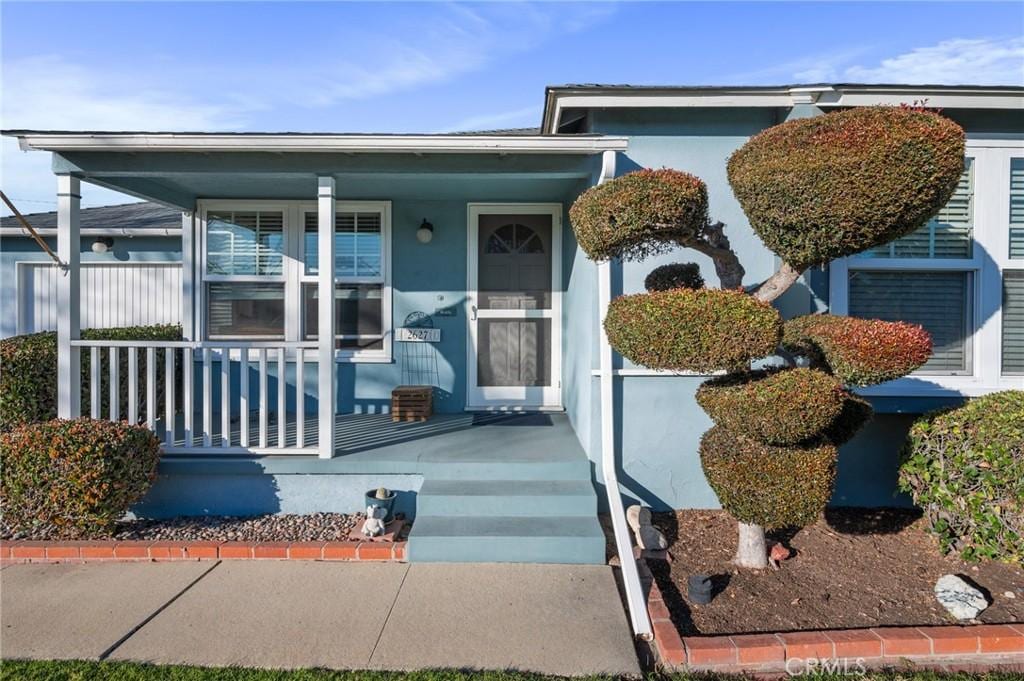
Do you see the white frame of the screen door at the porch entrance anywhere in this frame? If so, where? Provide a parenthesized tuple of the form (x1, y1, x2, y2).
(466, 203, 563, 411)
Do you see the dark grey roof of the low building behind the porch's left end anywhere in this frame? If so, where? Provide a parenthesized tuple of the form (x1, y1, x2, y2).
(0, 201, 181, 237)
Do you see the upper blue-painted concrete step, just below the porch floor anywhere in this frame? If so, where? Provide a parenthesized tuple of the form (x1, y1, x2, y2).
(416, 479, 597, 517)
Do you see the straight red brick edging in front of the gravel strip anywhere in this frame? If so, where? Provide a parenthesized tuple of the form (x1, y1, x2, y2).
(0, 540, 407, 564)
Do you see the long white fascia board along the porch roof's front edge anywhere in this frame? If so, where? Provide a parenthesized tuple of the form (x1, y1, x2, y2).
(12, 132, 629, 154)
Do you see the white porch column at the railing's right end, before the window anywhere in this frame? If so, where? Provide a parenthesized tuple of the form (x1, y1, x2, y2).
(316, 177, 337, 459)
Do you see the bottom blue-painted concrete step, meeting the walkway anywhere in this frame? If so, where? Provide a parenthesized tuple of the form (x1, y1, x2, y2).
(409, 513, 604, 564)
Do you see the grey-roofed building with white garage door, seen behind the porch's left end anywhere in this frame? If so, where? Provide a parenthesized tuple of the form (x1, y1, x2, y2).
(0, 202, 181, 338)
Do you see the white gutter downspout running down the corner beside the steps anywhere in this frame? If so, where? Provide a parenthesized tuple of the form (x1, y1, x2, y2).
(597, 147, 653, 641)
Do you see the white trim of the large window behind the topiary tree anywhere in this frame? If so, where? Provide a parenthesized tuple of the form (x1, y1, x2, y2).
(828, 136, 1024, 397)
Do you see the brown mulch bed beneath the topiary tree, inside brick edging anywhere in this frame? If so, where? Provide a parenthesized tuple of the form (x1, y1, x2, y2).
(648, 509, 1024, 636)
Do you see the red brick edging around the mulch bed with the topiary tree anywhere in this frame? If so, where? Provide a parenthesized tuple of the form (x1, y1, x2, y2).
(638, 558, 1024, 673)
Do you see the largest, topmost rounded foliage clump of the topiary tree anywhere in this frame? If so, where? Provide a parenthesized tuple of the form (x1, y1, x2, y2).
(728, 107, 964, 269)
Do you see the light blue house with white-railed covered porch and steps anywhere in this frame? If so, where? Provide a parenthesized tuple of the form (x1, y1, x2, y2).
(3, 84, 1024, 562)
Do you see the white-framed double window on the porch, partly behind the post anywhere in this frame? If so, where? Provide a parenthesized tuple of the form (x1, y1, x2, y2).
(201, 201, 391, 360)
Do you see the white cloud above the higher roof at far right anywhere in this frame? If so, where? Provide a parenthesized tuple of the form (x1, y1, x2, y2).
(843, 38, 1024, 85)
